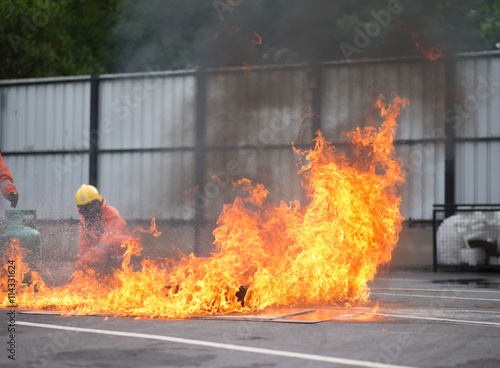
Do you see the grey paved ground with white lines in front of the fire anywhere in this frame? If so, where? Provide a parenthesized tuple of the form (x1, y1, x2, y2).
(0, 271, 500, 368)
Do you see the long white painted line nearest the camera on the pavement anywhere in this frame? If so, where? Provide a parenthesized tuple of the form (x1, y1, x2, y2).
(16, 321, 415, 368)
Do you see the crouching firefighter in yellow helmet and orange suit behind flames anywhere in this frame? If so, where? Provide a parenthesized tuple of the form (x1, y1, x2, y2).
(75, 184, 132, 274)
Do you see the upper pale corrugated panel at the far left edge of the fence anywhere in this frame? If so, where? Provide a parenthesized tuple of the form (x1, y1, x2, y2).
(0, 82, 90, 151)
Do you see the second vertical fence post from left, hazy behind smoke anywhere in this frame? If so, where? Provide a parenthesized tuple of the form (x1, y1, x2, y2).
(193, 69, 207, 256)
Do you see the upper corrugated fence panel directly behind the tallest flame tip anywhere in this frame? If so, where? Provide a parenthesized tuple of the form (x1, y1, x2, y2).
(322, 61, 444, 140)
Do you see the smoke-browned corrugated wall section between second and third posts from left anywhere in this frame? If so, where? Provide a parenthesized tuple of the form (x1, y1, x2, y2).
(203, 68, 312, 221)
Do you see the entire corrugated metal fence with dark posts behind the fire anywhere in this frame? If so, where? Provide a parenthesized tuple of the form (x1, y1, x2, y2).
(0, 52, 500, 253)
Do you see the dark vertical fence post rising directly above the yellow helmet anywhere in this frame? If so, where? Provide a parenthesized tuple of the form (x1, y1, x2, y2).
(89, 74, 99, 187)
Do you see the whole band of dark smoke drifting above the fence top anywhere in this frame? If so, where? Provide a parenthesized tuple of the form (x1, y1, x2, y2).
(116, 0, 488, 71)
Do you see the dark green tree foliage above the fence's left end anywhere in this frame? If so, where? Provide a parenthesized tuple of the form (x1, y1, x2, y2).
(0, 0, 119, 78)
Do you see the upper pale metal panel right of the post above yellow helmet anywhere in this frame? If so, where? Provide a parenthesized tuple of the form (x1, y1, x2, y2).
(99, 76, 196, 149)
